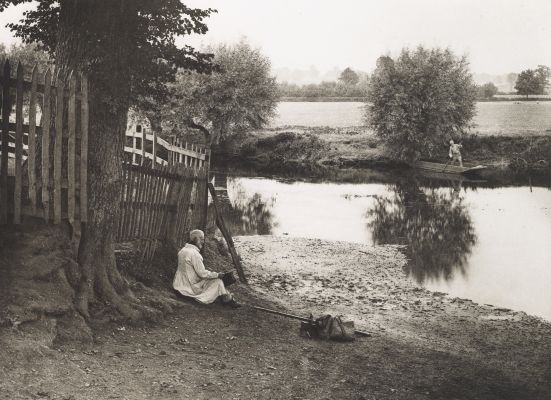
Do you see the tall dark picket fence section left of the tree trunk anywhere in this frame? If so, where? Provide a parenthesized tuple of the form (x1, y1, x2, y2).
(0, 60, 88, 224)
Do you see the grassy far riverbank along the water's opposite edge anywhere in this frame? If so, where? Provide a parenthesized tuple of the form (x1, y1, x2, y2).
(213, 126, 551, 183)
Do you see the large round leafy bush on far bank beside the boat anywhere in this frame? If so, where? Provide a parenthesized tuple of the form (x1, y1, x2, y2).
(366, 47, 476, 160)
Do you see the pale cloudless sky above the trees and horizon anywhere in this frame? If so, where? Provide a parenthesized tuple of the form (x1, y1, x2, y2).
(0, 0, 551, 74)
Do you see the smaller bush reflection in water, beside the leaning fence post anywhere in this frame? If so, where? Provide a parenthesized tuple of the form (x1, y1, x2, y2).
(220, 179, 278, 236)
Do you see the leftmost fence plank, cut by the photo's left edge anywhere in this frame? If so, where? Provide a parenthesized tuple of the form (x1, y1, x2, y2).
(0, 60, 11, 224)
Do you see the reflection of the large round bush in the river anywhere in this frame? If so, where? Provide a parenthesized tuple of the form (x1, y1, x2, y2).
(367, 180, 477, 283)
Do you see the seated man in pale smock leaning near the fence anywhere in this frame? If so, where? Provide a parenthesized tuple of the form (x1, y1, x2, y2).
(172, 229, 240, 308)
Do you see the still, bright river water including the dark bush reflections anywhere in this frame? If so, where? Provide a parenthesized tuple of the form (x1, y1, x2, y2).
(216, 170, 551, 320)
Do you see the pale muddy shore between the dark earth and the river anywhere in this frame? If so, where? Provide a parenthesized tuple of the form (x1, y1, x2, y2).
(235, 235, 551, 390)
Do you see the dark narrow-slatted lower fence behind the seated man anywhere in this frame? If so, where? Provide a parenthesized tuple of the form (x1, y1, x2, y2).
(117, 163, 208, 260)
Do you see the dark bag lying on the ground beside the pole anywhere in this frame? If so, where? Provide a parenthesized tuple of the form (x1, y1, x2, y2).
(300, 315, 355, 342)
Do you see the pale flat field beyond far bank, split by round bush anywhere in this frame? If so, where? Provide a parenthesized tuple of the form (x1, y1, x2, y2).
(272, 101, 551, 135)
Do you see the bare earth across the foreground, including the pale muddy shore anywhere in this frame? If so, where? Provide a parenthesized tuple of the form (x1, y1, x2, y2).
(0, 236, 551, 400)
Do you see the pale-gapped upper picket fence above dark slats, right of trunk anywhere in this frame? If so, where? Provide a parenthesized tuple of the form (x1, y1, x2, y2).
(124, 124, 210, 169)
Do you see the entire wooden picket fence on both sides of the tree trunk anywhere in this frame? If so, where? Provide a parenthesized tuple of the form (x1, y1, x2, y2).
(0, 61, 210, 259)
